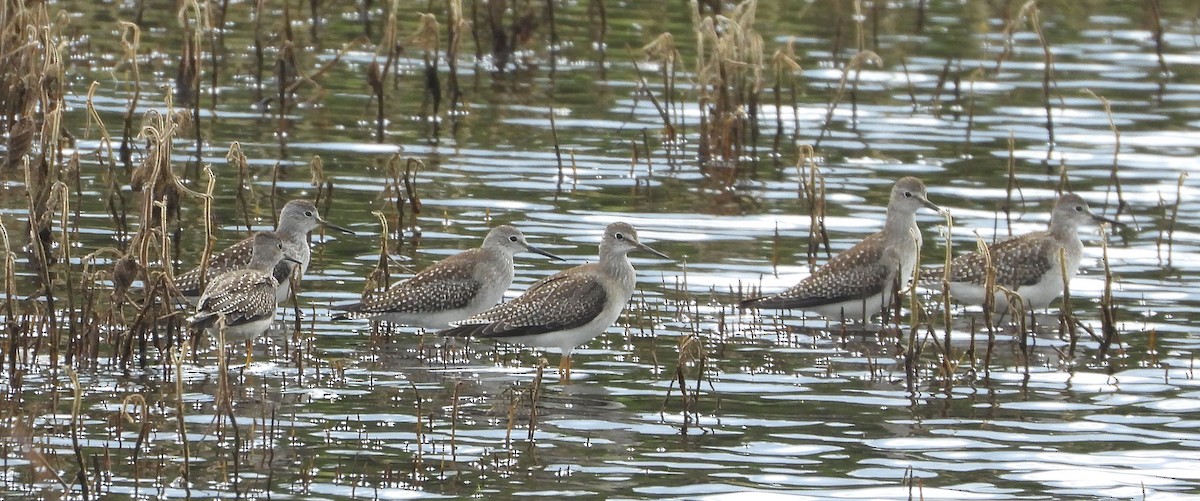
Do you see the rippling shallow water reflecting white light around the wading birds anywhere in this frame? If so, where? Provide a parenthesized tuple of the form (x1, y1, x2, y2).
(0, 2, 1200, 500)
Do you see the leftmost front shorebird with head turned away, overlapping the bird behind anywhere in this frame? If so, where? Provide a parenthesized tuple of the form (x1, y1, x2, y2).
(188, 231, 299, 342)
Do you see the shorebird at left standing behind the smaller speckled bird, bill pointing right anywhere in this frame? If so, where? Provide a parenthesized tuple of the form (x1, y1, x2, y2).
(175, 200, 354, 303)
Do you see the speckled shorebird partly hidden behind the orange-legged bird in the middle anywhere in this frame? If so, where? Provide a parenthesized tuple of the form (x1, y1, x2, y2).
(334, 225, 563, 328)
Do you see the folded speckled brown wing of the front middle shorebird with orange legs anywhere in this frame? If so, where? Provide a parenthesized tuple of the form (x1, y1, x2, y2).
(442, 269, 608, 338)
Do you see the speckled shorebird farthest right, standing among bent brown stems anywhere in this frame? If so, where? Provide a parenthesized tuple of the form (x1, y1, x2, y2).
(922, 193, 1121, 313)
